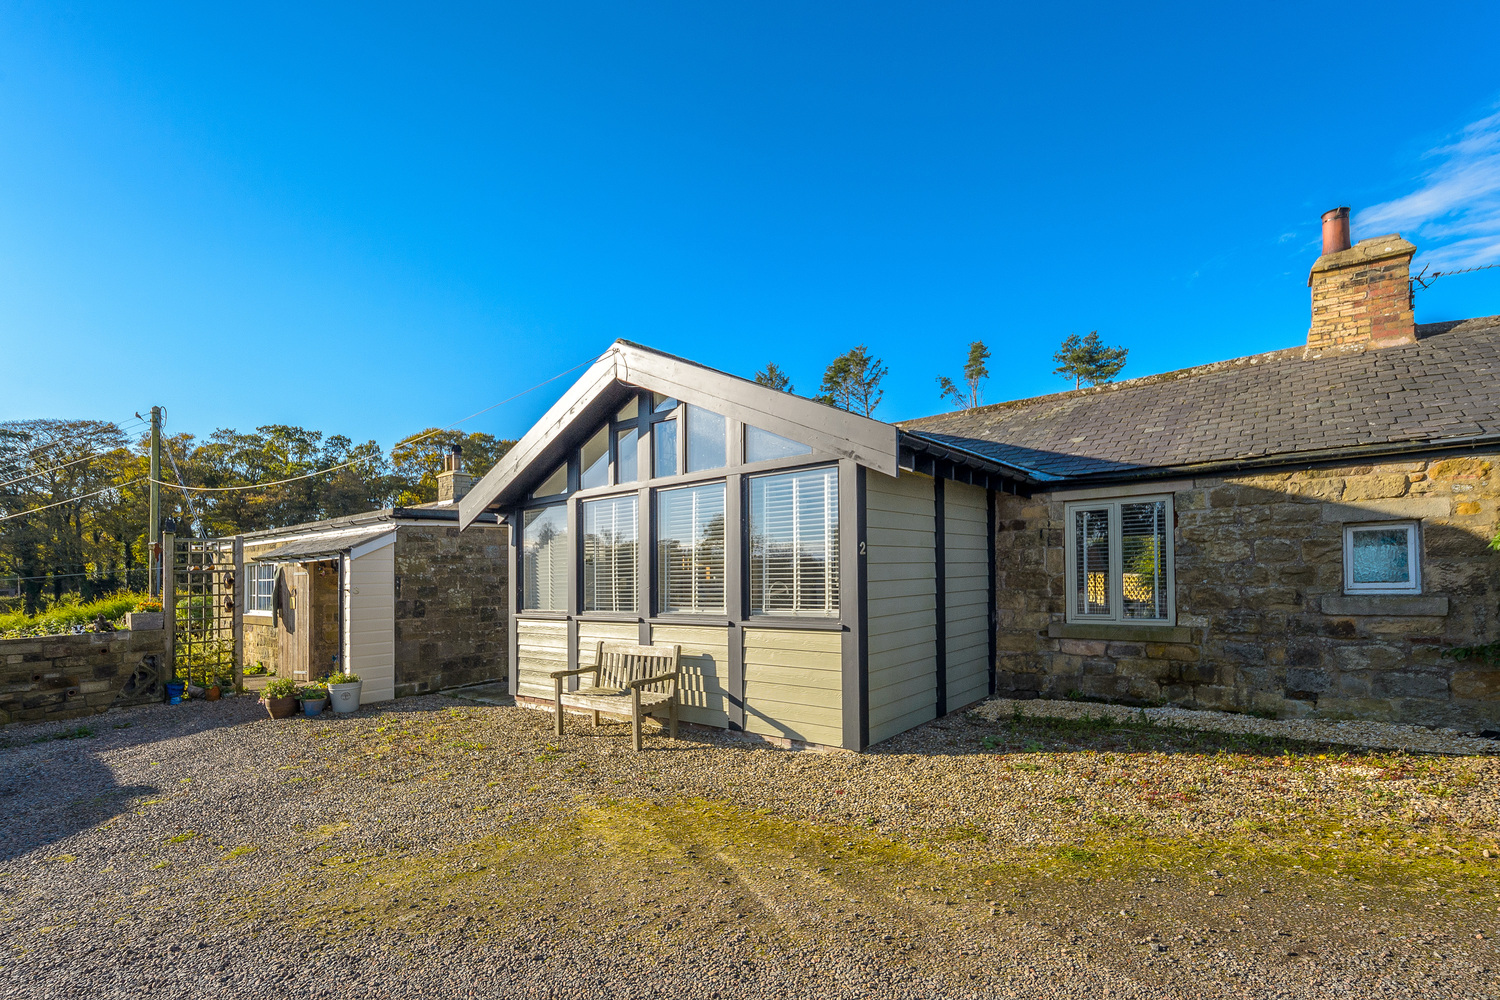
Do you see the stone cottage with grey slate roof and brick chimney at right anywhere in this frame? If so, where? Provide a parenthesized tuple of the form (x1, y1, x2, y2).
(902, 208, 1500, 729)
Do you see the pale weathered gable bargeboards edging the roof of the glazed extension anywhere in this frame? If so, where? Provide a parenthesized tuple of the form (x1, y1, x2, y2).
(459, 340, 897, 528)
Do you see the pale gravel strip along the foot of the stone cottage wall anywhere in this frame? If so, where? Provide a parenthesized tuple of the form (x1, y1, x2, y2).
(975, 699, 1500, 754)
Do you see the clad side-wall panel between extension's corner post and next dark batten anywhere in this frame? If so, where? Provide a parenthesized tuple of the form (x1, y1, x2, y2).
(864, 471, 938, 744)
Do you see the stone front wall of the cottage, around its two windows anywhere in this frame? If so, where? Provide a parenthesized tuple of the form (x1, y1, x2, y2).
(996, 453, 1500, 729)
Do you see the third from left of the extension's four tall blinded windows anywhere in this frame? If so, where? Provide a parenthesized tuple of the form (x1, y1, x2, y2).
(657, 482, 725, 615)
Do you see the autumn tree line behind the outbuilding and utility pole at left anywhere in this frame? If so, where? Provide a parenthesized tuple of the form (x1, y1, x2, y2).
(0, 420, 515, 612)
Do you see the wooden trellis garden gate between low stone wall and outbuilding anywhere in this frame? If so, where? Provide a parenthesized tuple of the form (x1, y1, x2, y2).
(162, 534, 242, 690)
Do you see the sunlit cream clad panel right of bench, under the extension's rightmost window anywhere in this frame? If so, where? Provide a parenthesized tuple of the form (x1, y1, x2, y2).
(744, 628, 843, 747)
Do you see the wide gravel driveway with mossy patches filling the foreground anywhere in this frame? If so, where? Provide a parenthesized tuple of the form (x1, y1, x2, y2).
(0, 697, 1500, 1000)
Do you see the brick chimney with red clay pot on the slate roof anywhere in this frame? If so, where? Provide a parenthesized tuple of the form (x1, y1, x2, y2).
(1308, 208, 1416, 348)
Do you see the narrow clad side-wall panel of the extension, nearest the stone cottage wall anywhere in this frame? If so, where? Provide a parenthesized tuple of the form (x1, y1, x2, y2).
(944, 481, 990, 712)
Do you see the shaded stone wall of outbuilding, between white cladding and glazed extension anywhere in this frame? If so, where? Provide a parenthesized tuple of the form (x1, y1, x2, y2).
(396, 525, 510, 697)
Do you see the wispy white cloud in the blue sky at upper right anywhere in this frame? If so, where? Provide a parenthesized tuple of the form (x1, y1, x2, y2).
(1355, 112, 1500, 270)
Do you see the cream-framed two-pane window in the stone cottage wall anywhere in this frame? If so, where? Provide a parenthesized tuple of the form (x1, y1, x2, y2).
(1064, 496, 1176, 625)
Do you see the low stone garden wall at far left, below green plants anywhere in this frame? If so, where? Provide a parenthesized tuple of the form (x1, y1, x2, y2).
(0, 628, 167, 724)
